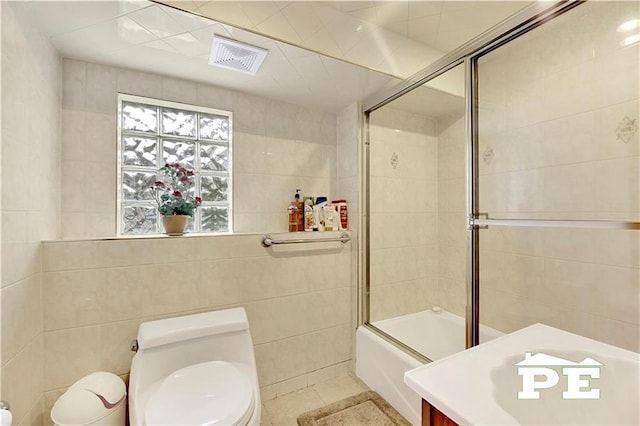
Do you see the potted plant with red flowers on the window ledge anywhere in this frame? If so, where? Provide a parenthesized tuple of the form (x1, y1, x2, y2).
(152, 163, 202, 235)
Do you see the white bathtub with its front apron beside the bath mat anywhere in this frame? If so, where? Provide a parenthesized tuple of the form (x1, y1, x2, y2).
(356, 310, 503, 425)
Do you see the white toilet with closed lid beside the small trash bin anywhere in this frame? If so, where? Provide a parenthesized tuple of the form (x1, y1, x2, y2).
(129, 308, 261, 426)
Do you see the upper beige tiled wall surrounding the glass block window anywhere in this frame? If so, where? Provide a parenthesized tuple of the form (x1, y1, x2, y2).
(61, 59, 337, 239)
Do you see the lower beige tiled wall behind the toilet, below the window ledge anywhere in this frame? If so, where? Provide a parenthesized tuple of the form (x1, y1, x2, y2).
(43, 234, 354, 410)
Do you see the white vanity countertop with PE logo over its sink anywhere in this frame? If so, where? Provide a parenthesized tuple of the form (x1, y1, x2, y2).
(404, 324, 640, 425)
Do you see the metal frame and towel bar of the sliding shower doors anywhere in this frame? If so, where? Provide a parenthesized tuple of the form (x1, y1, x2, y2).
(358, 0, 608, 352)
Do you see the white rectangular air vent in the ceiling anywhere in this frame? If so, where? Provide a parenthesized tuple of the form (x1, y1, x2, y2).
(209, 35, 268, 75)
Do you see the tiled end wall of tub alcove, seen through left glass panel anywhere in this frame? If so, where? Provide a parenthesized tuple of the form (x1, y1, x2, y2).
(370, 108, 444, 322)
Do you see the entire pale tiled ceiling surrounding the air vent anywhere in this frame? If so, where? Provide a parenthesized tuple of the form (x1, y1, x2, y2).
(26, 0, 526, 111)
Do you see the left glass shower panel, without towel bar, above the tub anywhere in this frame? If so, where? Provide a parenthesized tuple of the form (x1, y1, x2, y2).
(368, 65, 466, 359)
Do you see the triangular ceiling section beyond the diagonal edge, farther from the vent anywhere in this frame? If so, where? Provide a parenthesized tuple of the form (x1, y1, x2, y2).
(160, 0, 531, 78)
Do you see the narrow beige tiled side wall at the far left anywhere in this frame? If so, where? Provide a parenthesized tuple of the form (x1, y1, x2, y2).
(0, 2, 62, 425)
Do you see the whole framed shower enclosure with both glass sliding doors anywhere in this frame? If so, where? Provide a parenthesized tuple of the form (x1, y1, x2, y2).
(356, 2, 640, 422)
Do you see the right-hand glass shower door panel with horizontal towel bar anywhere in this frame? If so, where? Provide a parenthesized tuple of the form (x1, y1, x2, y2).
(477, 2, 640, 352)
